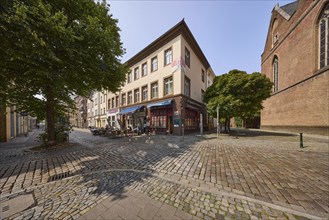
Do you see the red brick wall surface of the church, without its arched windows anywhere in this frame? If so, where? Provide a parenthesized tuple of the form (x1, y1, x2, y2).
(261, 0, 329, 134)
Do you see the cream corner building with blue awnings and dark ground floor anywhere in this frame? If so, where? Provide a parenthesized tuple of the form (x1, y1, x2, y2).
(107, 20, 215, 135)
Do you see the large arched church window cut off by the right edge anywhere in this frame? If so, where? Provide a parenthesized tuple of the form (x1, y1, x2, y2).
(319, 4, 329, 69)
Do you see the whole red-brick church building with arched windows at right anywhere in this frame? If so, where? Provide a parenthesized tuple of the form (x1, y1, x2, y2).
(261, 0, 329, 135)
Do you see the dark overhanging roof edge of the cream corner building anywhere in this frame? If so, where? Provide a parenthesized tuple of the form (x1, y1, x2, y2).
(126, 19, 210, 69)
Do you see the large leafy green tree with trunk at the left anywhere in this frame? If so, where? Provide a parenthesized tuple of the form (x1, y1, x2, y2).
(0, 0, 127, 145)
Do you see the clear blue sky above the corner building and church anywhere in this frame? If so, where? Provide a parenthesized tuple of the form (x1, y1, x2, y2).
(107, 0, 293, 75)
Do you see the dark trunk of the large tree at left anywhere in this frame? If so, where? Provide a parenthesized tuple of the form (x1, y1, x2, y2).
(45, 84, 56, 146)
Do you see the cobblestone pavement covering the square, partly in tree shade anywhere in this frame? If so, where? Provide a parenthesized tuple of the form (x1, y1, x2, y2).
(0, 129, 329, 219)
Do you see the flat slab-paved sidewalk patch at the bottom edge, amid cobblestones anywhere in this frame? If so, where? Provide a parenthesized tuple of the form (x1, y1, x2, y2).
(78, 187, 200, 220)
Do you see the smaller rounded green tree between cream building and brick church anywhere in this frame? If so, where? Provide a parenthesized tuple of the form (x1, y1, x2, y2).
(204, 70, 272, 130)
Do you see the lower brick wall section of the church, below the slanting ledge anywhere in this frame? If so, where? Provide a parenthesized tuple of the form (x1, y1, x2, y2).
(261, 70, 329, 135)
